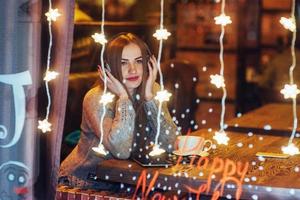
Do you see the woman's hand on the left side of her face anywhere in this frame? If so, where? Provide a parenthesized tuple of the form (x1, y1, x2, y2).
(98, 65, 128, 99)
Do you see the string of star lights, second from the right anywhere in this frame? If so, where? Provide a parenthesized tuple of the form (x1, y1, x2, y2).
(210, 0, 232, 145)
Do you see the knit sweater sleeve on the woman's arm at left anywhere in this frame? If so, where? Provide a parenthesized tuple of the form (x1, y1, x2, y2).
(83, 87, 135, 159)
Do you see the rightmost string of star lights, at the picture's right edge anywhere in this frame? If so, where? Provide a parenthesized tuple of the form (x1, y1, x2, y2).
(280, 0, 300, 155)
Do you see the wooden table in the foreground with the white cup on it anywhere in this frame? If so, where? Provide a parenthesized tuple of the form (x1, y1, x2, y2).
(97, 130, 300, 199)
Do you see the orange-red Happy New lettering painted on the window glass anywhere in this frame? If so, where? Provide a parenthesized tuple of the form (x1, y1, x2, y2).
(133, 157, 249, 200)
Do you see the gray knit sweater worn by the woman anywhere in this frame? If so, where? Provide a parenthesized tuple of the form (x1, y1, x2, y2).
(59, 84, 179, 186)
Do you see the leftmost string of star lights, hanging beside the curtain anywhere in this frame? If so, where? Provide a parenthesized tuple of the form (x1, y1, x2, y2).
(38, 0, 61, 133)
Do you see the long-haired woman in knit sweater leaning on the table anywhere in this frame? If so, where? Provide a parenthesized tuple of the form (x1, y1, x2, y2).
(59, 33, 179, 189)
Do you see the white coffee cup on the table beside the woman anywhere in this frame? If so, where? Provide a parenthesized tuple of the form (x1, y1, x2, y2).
(176, 135, 212, 155)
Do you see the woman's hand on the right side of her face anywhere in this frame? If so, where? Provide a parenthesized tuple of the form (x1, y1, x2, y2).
(145, 56, 157, 101)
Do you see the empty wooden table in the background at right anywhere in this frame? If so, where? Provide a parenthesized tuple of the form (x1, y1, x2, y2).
(226, 104, 300, 136)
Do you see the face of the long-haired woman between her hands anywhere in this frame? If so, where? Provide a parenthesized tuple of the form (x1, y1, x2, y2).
(121, 43, 143, 94)
